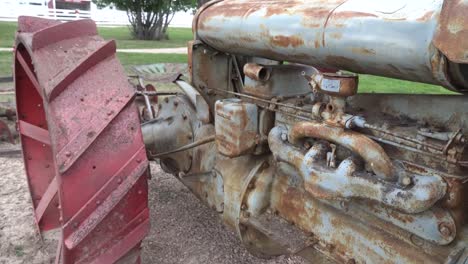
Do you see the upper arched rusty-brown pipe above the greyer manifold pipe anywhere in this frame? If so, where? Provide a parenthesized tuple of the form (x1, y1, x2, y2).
(289, 122, 398, 181)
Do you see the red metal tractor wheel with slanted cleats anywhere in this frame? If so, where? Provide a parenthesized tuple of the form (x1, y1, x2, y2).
(14, 17, 150, 263)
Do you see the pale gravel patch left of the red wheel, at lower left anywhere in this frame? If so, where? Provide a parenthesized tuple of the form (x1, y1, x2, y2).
(0, 157, 56, 264)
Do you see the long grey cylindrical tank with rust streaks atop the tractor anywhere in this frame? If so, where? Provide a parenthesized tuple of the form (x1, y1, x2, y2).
(194, 0, 468, 90)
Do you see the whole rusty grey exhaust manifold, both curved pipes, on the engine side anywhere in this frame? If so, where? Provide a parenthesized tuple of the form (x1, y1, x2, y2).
(268, 122, 447, 214)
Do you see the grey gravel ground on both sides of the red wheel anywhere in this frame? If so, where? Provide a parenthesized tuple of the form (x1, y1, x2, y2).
(0, 154, 306, 264)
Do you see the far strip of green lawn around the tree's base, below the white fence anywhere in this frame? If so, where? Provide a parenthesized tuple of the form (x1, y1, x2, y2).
(0, 22, 192, 49)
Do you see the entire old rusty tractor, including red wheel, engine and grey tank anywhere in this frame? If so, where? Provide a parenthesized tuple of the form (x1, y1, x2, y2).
(14, 0, 468, 263)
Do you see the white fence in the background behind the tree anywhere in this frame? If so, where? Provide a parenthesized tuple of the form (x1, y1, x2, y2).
(0, 0, 193, 27)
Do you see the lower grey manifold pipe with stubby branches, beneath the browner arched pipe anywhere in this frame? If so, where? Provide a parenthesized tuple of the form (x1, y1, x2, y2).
(268, 127, 447, 214)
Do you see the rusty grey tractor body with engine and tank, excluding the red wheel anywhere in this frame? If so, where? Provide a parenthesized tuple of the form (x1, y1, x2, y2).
(142, 0, 468, 263)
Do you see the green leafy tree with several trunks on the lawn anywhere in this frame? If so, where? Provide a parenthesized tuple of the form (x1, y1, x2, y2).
(93, 0, 197, 40)
